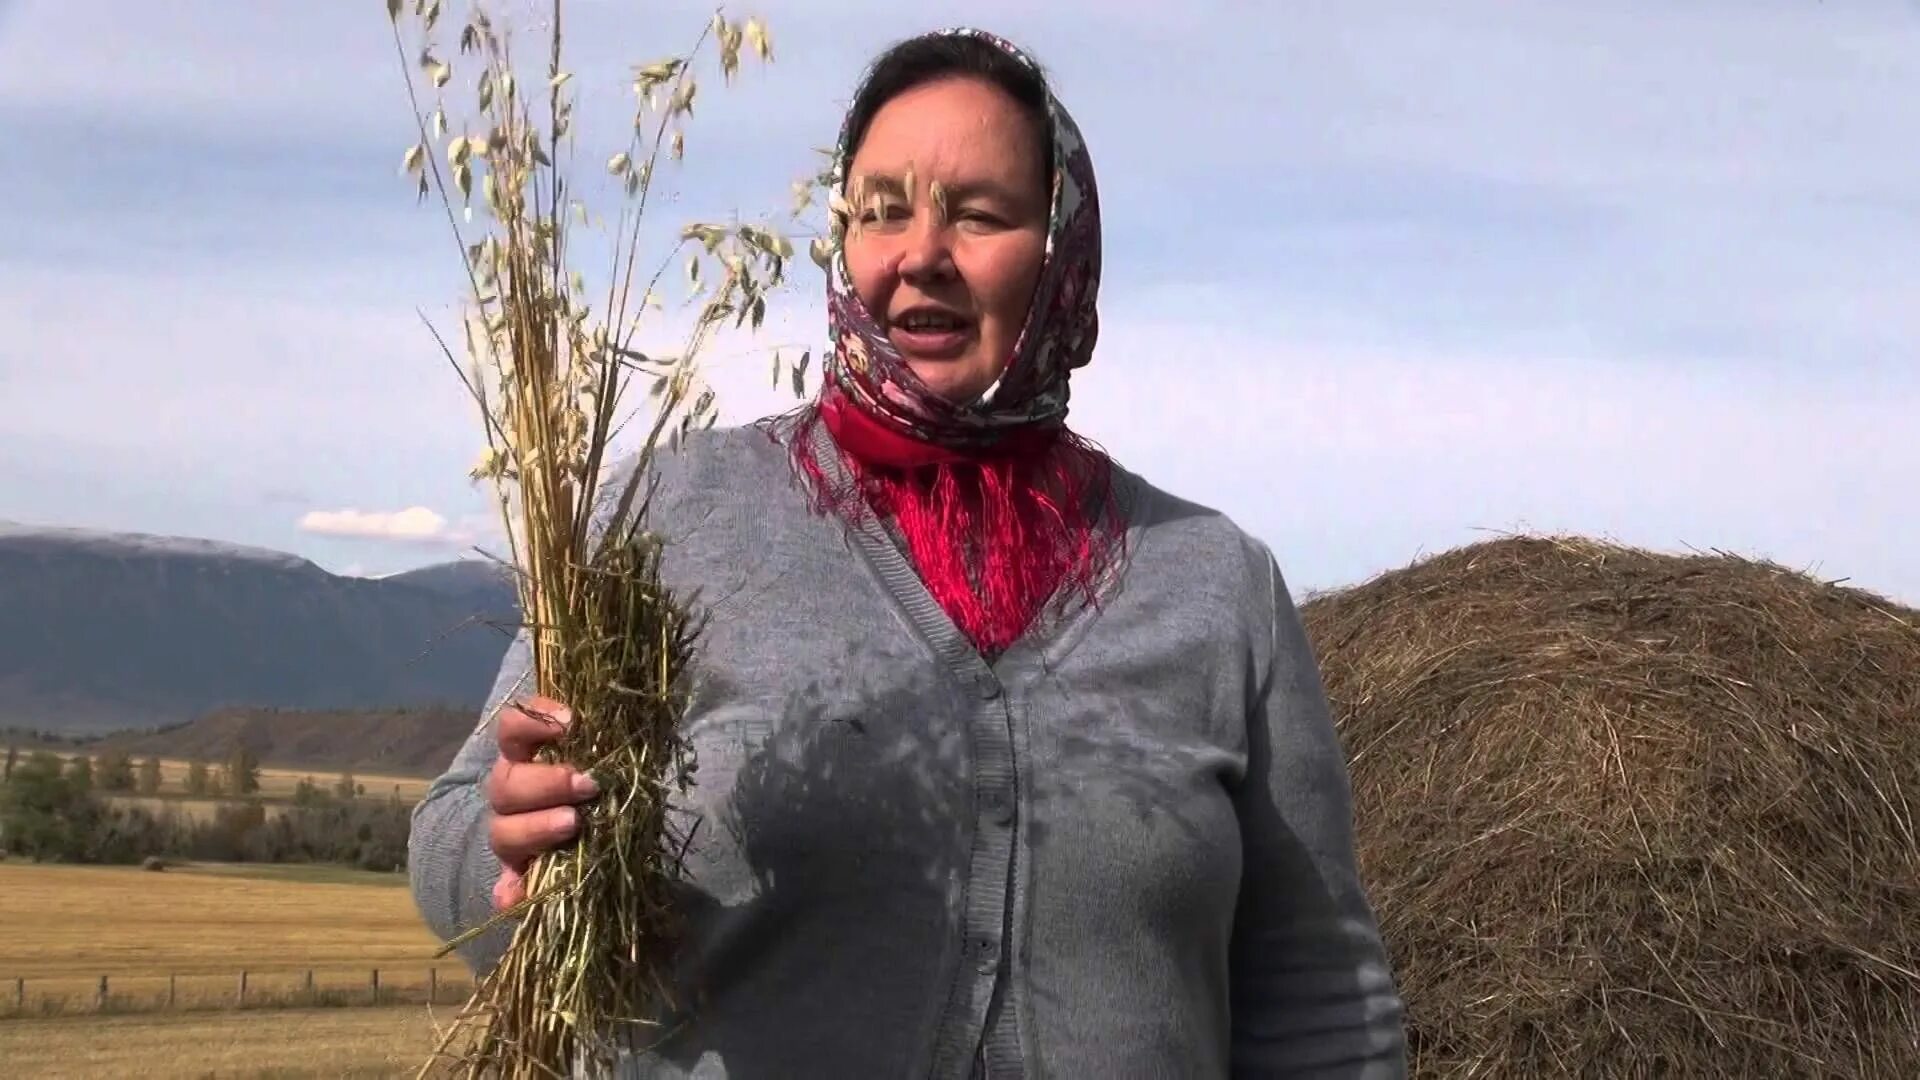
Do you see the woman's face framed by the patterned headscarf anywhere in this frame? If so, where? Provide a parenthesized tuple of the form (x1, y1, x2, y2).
(847, 77, 1050, 404)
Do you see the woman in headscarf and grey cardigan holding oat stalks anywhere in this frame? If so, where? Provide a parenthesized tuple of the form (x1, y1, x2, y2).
(411, 31, 1404, 1080)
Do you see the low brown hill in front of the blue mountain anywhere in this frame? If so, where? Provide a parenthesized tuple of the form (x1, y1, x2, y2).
(88, 707, 480, 776)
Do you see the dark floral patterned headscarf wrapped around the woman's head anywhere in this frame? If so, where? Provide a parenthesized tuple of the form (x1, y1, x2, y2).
(826, 27, 1100, 450)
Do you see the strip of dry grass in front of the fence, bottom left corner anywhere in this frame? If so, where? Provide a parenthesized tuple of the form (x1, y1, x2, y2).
(0, 1007, 451, 1080)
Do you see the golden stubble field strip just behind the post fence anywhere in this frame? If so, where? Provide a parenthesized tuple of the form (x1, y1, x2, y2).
(0, 861, 467, 1014)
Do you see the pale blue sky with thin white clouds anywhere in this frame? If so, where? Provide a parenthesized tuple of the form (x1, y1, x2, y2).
(0, 0, 1920, 603)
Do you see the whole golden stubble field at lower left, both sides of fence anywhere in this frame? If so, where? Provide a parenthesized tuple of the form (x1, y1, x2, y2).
(0, 859, 468, 1078)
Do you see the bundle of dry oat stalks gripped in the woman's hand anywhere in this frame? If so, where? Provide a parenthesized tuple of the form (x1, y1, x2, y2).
(388, 0, 804, 1076)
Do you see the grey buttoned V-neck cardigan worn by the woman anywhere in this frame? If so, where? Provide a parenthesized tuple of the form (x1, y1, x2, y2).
(409, 413, 1405, 1080)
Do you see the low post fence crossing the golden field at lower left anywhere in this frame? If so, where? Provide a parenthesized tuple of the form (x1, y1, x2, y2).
(0, 967, 472, 1019)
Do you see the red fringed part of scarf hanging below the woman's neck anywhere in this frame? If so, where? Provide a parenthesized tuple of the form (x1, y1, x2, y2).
(795, 394, 1125, 657)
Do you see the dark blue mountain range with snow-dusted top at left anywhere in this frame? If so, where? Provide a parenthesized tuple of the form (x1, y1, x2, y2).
(0, 523, 515, 734)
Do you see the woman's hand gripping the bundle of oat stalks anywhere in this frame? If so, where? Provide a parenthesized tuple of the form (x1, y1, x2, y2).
(486, 698, 599, 911)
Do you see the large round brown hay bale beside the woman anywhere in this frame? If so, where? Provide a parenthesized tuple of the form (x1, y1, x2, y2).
(1302, 536, 1920, 1078)
